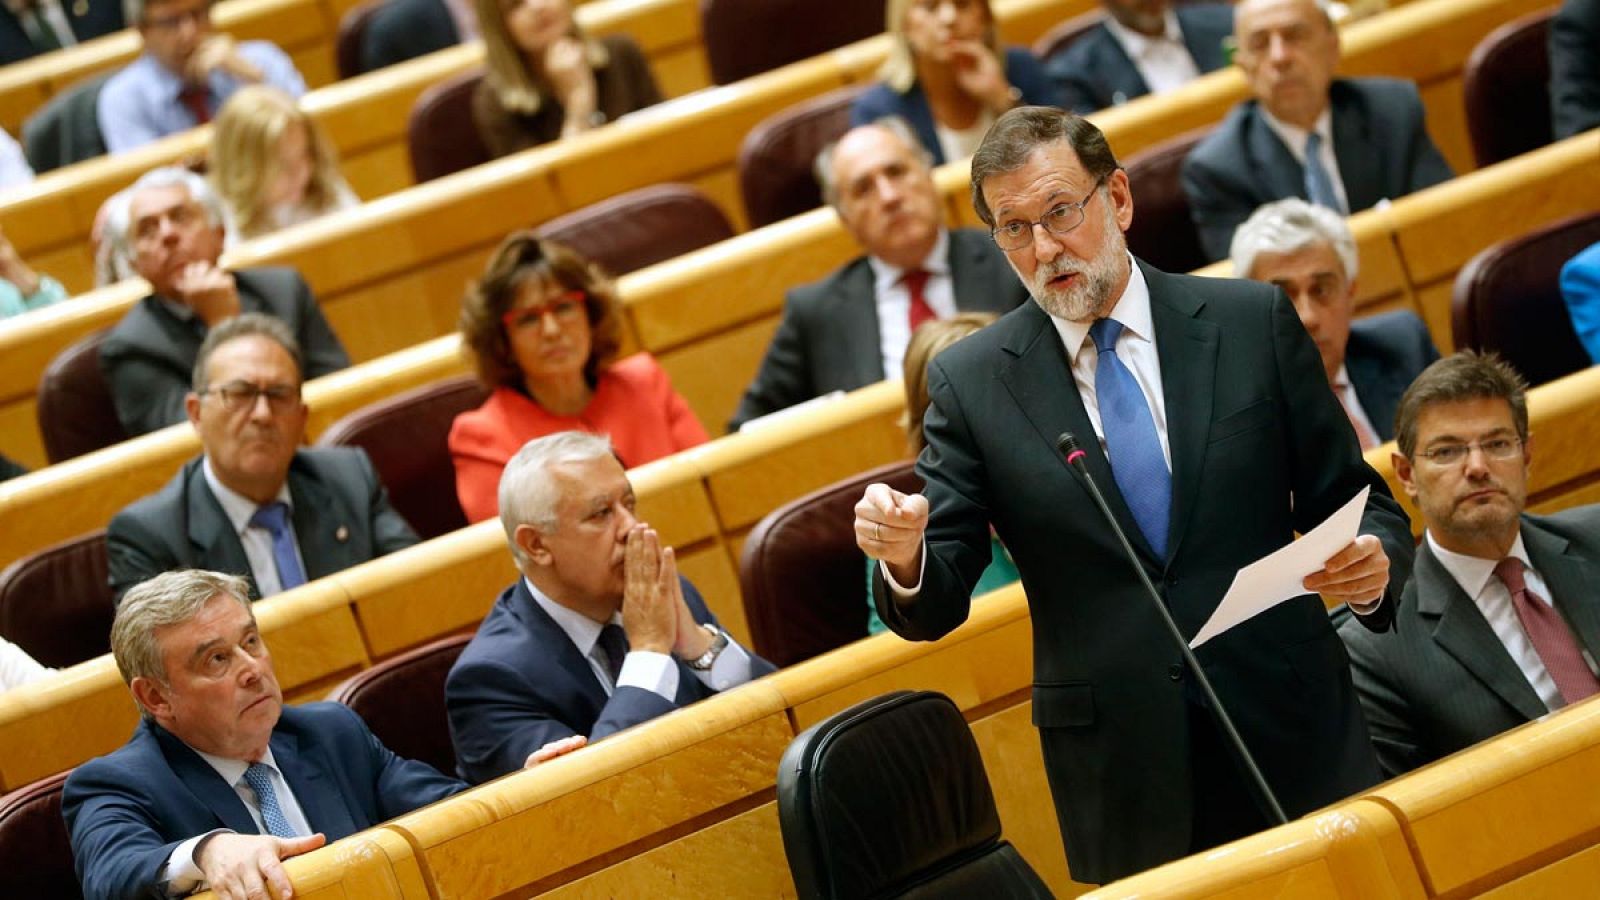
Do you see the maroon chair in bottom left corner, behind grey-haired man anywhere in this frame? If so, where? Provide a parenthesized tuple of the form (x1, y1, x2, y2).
(0, 772, 83, 900)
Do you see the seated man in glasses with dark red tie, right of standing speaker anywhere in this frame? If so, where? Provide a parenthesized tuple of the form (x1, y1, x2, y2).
(1339, 351, 1600, 775)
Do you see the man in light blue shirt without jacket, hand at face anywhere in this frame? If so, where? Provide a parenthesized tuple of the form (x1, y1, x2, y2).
(96, 0, 306, 154)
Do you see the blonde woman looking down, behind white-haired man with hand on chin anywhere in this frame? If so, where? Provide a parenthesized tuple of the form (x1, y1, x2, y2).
(210, 85, 360, 239)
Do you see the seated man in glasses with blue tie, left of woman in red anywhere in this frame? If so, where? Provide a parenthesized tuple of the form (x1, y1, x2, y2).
(106, 312, 418, 599)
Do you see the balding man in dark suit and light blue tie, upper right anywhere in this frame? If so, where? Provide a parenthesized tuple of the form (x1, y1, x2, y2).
(1182, 0, 1451, 259)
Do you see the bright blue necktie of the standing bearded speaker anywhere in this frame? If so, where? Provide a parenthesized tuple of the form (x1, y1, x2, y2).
(1090, 319, 1173, 559)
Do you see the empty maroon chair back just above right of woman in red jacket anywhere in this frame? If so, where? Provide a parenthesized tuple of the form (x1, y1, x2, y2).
(534, 184, 733, 275)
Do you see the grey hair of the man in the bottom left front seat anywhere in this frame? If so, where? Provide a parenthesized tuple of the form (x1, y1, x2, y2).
(110, 569, 256, 684)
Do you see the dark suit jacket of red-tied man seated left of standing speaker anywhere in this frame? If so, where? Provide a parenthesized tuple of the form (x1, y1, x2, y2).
(728, 229, 1027, 431)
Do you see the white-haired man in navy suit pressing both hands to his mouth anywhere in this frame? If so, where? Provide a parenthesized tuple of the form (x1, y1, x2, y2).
(445, 431, 773, 783)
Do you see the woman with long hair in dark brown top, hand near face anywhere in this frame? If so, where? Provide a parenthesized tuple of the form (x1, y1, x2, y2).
(472, 0, 661, 157)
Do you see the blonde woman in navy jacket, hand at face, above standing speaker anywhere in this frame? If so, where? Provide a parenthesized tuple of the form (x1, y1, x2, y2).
(850, 0, 1059, 165)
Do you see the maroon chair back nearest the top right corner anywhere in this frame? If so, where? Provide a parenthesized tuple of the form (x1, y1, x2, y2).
(1461, 5, 1555, 167)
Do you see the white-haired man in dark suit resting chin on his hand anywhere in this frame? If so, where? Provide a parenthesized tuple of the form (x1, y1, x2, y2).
(99, 167, 350, 436)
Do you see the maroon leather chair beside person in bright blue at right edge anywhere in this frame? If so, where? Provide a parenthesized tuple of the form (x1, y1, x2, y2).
(1450, 213, 1600, 384)
